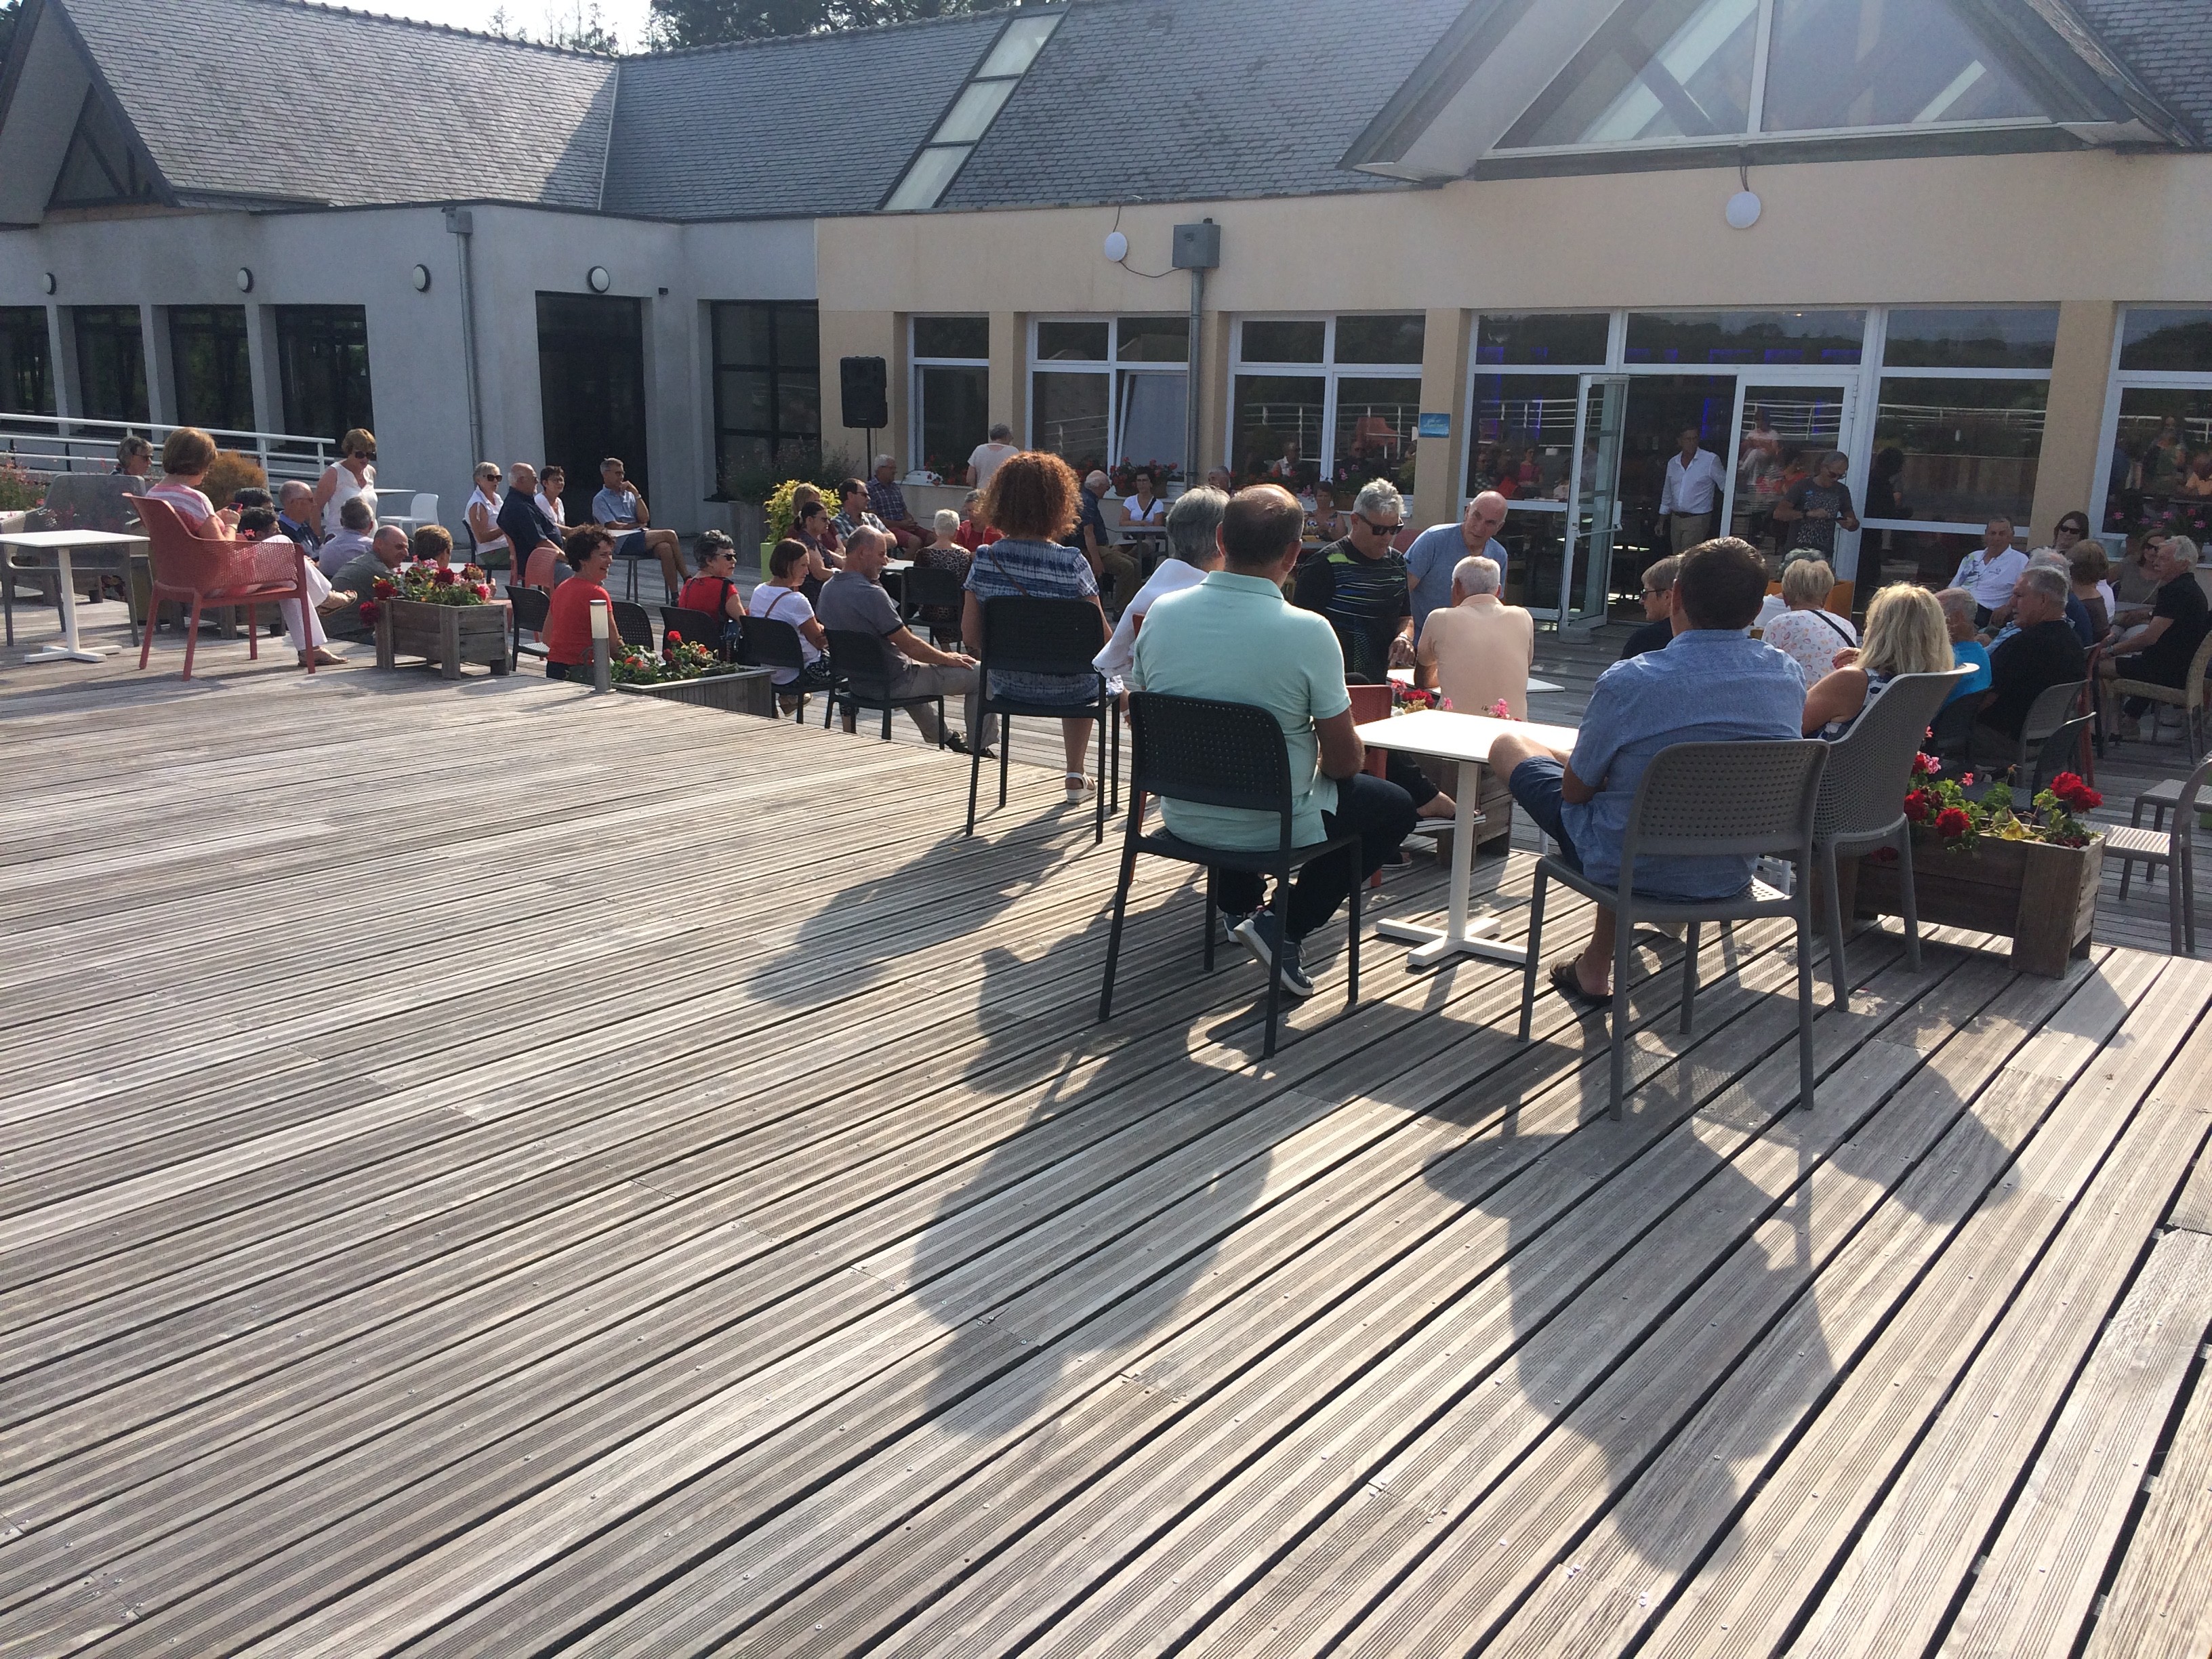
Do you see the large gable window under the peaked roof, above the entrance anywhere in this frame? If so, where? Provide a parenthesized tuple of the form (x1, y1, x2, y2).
(1498, 0, 2079, 155)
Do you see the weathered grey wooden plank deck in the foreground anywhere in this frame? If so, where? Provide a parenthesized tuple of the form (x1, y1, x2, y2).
(0, 601, 2212, 1659)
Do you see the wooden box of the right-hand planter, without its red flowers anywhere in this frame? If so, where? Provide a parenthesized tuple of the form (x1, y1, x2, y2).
(1838, 830, 2104, 980)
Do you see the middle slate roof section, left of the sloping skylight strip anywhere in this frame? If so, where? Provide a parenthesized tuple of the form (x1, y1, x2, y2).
(597, 11, 1006, 219)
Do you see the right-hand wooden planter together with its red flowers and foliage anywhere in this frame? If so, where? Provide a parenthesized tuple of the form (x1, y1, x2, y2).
(1838, 754, 2104, 978)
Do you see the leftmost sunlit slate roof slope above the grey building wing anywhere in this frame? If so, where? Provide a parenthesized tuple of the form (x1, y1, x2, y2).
(47, 0, 615, 208)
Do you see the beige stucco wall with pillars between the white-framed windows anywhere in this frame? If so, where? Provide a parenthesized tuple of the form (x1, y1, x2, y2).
(816, 152, 2212, 531)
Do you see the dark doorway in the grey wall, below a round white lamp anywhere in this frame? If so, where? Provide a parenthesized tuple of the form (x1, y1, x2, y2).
(537, 294, 653, 525)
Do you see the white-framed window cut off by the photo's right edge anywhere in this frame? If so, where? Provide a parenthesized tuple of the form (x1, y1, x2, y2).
(2090, 305, 2212, 546)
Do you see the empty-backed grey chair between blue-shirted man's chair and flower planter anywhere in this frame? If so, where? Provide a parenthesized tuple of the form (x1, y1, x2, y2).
(1811, 668, 1971, 1008)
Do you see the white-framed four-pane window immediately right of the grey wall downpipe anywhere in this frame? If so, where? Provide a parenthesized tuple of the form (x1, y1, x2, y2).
(1228, 312, 1427, 489)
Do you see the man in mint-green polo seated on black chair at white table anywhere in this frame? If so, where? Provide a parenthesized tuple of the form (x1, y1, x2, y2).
(1128, 485, 1414, 998)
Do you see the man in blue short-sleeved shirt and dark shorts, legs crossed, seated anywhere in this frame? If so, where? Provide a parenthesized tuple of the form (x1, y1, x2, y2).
(1491, 546, 1805, 1002)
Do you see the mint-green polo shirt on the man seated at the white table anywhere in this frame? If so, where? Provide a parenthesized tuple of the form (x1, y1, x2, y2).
(1128, 571, 1351, 849)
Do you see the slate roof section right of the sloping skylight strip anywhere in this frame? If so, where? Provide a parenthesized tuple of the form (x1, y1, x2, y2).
(940, 0, 1467, 208)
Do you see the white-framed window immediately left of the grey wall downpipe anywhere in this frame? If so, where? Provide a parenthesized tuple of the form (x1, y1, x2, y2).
(1029, 314, 1190, 485)
